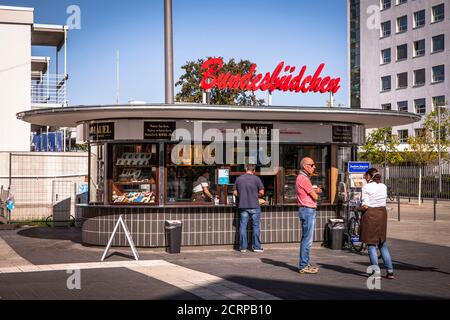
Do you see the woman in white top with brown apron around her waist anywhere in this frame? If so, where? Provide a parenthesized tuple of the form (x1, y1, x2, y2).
(360, 168, 394, 279)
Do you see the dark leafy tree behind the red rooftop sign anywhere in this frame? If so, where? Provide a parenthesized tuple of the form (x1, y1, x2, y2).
(175, 59, 264, 106)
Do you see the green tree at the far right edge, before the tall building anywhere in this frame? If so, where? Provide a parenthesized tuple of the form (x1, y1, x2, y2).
(406, 106, 450, 165)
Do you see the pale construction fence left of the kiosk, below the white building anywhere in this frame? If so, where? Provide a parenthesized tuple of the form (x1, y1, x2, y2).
(0, 152, 88, 221)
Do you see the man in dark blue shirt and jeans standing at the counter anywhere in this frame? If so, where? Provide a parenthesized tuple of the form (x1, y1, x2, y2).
(233, 164, 264, 253)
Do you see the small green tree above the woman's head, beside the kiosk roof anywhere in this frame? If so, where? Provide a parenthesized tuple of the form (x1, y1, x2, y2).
(360, 128, 404, 165)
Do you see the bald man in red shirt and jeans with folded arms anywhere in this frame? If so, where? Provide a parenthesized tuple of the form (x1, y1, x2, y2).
(295, 157, 322, 274)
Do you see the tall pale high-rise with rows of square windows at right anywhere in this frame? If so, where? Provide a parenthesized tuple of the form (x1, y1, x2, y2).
(348, 0, 450, 148)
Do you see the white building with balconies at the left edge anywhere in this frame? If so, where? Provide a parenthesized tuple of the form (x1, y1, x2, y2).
(0, 6, 70, 152)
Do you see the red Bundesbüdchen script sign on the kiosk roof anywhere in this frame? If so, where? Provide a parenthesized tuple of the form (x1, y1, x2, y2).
(200, 58, 341, 93)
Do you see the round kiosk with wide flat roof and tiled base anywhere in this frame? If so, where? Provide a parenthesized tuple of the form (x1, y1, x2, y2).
(17, 104, 419, 247)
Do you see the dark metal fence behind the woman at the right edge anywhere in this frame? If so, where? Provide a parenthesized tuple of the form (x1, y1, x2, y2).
(374, 163, 450, 200)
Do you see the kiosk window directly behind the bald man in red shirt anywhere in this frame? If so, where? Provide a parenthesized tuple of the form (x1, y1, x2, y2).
(281, 145, 331, 203)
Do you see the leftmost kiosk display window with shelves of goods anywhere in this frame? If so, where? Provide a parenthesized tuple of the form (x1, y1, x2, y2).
(109, 143, 159, 205)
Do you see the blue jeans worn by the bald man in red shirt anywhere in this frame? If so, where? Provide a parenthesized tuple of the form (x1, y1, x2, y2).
(298, 207, 316, 269)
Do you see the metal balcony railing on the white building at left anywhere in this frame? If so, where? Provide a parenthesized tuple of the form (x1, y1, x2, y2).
(31, 74, 68, 107)
